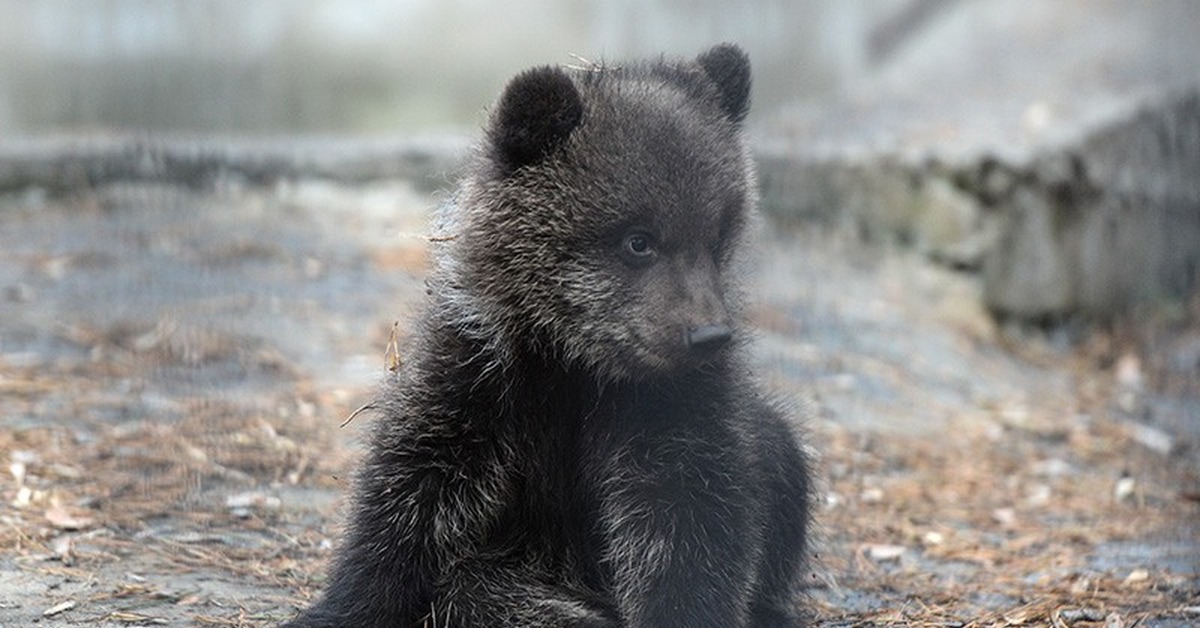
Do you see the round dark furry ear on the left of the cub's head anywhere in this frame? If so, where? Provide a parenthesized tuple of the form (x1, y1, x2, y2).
(488, 66, 583, 175)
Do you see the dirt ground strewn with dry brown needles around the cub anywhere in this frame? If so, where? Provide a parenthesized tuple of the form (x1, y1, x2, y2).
(0, 183, 1200, 628)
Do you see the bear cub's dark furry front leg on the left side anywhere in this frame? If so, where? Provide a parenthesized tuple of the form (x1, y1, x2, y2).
(286, 414, 514, 628)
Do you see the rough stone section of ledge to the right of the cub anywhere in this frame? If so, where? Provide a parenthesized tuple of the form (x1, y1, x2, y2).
(760, 90, 1200, 319)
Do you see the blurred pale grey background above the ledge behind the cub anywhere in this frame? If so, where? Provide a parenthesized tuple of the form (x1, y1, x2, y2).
(0, 0, 1185, 136)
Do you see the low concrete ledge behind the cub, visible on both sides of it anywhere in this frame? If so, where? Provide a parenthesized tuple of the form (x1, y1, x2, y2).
(0, 90, 1200, 321)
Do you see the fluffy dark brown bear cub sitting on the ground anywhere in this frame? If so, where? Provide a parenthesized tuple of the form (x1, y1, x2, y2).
(288, 44, 810, 628)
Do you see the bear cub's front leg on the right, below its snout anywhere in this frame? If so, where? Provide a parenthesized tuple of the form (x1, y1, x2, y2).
(598, 431, 761, 628)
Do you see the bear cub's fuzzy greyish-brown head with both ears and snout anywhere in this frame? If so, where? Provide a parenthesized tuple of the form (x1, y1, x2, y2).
(451, 44, 755, 381)
